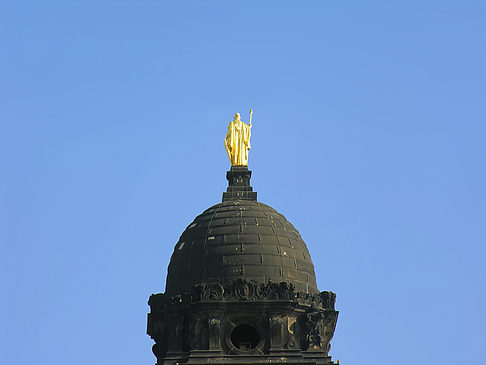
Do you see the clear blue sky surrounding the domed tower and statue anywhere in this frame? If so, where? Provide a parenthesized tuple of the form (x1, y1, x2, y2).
(0, 0, 486, 365)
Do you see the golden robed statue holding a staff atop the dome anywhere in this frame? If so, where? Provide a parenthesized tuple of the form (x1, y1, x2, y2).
(224, 110, 253, 166)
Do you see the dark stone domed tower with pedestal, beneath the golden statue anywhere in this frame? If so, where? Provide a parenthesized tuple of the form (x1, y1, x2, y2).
(147, 112, 338, 365)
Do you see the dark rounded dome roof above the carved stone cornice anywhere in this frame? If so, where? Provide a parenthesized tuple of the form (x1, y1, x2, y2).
(166, 198, 319, 295)
